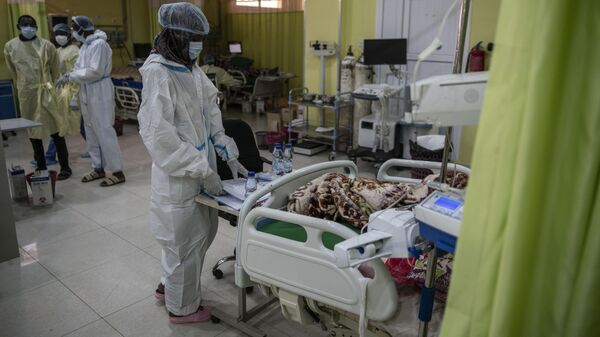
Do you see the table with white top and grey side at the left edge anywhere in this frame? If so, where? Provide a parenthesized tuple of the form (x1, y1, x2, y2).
(0, 118, 42, 262)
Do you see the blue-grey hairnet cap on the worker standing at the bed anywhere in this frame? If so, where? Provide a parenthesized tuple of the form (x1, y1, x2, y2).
(158, 2, 210, 35)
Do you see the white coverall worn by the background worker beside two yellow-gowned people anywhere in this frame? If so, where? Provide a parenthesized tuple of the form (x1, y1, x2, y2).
(70, 31, 123, 172)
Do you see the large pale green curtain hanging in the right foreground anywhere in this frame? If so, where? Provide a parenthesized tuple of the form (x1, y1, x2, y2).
(441, 0, 600, 337)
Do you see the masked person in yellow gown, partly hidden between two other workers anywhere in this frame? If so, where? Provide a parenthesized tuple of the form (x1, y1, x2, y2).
(39, 23, 81, 165)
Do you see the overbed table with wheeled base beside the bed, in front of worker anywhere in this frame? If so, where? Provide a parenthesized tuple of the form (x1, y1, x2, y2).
(195, 194, 277, 337)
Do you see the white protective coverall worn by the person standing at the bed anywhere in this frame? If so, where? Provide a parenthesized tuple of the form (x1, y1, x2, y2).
(138, 54, 238, 315)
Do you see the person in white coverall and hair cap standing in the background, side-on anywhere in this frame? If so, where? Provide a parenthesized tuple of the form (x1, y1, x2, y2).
(57, 16, 125, 186)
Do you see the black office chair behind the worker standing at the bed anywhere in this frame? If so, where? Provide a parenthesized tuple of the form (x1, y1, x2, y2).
(212, 119, 271, 279)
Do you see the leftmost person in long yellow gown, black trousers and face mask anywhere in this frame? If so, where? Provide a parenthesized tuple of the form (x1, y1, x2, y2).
(4, 15, 72, 180)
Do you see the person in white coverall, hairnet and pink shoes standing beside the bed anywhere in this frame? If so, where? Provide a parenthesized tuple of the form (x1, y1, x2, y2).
(138, 3, 248, 323)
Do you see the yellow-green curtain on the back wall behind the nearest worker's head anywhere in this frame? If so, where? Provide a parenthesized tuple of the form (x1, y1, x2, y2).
(224, 11, 304, 88)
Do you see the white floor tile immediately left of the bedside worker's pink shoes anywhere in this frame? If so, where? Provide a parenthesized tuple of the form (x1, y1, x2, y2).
(63, 251, 161, 317)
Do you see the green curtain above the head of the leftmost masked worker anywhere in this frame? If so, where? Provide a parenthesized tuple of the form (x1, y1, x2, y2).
(8, 0, 49, 39)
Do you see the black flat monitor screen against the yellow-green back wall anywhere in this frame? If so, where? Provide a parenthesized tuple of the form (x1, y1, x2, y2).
(364, 39, 406, 65)
